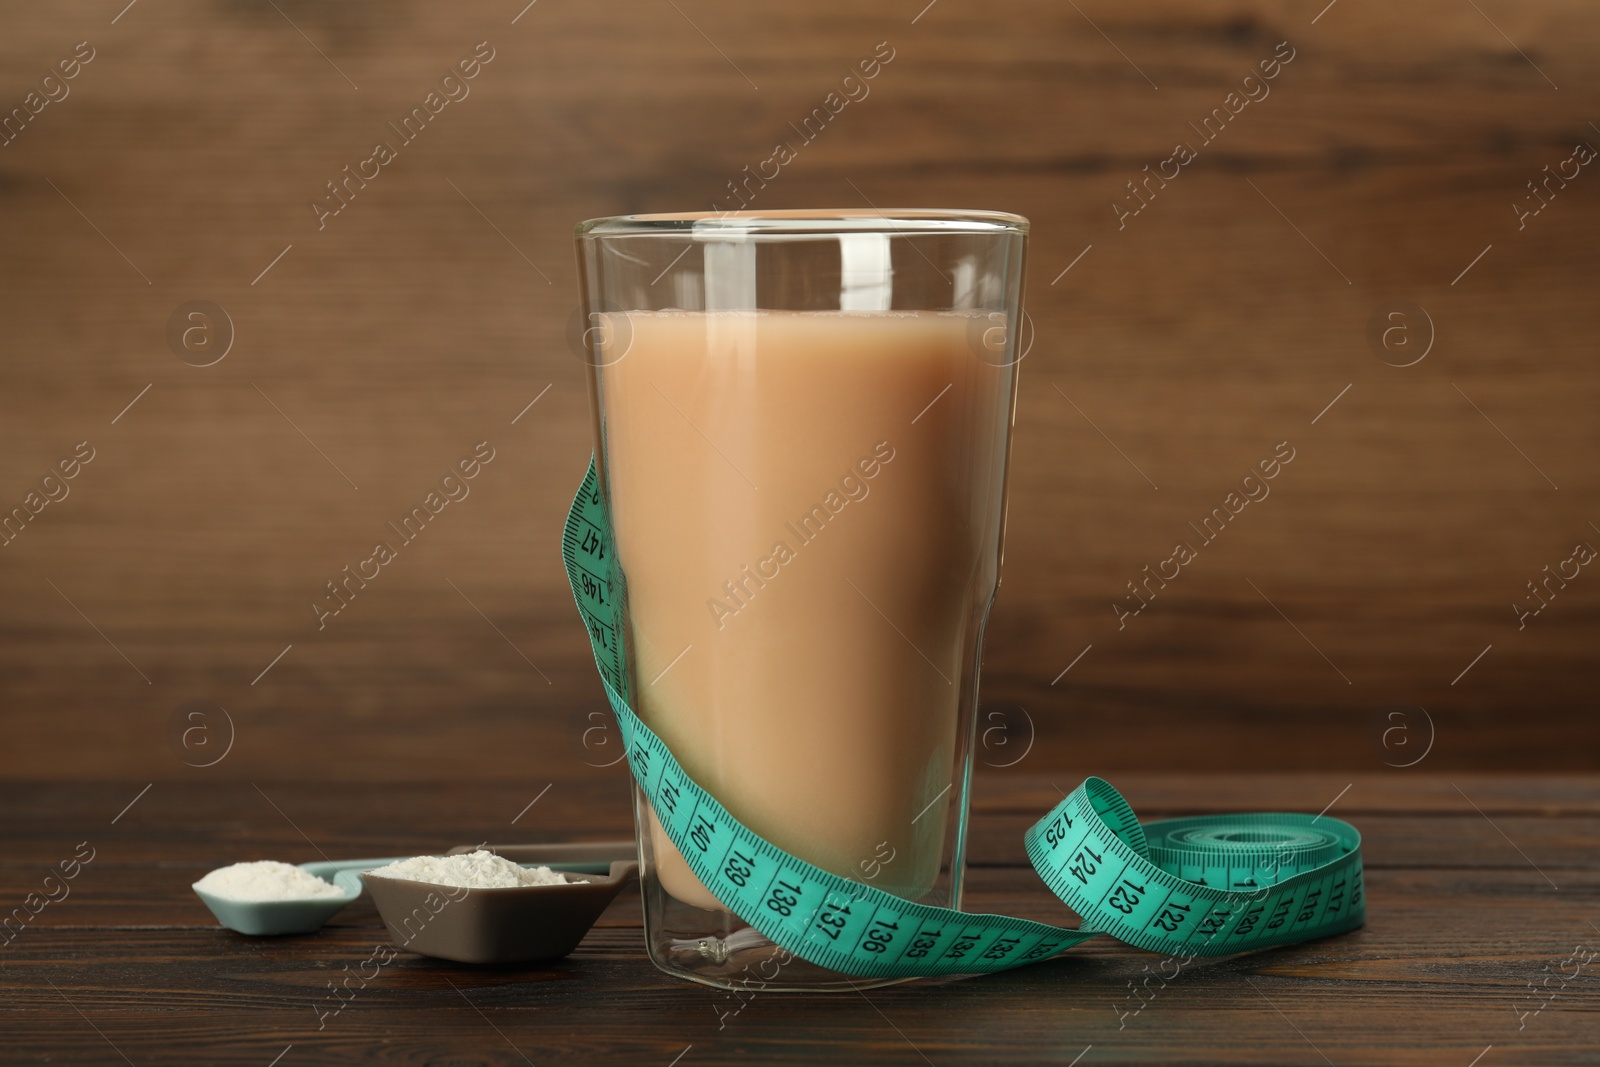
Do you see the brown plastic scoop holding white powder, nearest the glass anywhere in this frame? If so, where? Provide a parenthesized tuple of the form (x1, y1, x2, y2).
(362, 840, 638, 963)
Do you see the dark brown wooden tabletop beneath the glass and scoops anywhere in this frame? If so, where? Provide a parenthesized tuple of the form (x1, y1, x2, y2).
(0, 768, 1600, 1067)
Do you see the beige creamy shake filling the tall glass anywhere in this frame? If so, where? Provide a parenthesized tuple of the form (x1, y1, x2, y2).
(600, 310, 1013, 909)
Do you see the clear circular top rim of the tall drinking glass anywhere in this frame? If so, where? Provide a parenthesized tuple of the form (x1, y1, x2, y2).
(574, 208, 1029, 238)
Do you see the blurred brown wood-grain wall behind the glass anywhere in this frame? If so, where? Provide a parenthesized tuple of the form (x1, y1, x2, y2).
(0, 0, 1600, 781)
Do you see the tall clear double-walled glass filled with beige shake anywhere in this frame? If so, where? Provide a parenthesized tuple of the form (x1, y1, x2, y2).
(578, 211, 1027, 992)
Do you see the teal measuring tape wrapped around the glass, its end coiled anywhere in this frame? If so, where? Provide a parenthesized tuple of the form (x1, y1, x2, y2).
(562, 459, 1366, 977)
